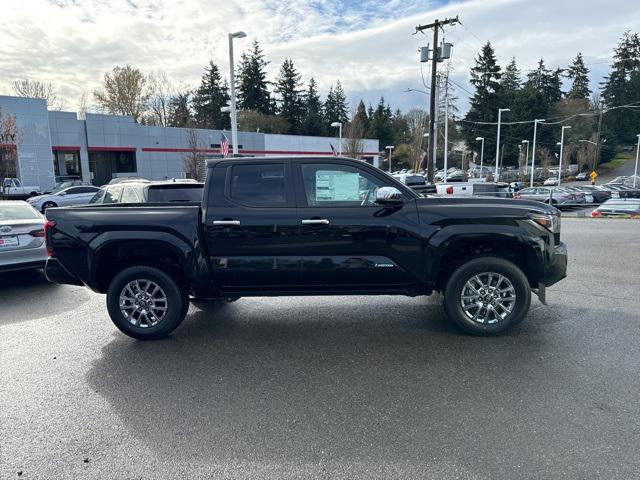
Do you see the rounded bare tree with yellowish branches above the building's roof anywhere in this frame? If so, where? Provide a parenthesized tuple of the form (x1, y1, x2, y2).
(93, 65, 149, 122)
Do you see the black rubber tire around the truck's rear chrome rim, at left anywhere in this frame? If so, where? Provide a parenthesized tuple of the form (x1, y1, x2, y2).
(107, 265, 189, 340)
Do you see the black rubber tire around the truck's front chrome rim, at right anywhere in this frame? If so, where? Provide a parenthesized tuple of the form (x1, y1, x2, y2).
(444, 257, 531, 335)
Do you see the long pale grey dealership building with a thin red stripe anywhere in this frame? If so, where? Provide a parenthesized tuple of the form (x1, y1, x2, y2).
(0, 96, 379, 190)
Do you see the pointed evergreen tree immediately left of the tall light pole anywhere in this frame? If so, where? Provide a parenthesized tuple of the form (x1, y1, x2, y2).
(193, 61, 231, 129)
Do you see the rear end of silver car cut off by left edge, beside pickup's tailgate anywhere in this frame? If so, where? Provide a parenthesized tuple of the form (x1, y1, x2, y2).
(0, 200, 47, 272)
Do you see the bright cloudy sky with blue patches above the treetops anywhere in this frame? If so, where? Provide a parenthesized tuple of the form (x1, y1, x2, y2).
(0, 0, 640, 115)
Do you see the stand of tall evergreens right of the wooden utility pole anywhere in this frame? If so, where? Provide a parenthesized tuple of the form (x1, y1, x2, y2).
(459, 32, 640, 168)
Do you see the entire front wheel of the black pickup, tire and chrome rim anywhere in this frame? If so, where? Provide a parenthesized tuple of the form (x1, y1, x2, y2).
(444, 257, 531, 335)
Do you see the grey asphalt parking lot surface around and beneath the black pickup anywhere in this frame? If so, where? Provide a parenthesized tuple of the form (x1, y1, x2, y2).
(0, 218, 640, 479)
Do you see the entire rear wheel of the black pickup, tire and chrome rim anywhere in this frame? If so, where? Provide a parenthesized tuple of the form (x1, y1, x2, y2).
(107, 265, 189, 340)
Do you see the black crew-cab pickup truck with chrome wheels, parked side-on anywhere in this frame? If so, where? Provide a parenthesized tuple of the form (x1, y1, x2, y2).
(46, 157, 567, 339)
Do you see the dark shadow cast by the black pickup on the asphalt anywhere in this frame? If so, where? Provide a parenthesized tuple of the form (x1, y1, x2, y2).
(88, 298, 571, 472)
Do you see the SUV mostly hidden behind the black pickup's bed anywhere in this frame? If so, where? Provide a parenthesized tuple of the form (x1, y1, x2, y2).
(89, 181, 204, 204)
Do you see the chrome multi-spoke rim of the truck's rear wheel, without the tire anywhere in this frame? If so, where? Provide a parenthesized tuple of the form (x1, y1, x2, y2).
(120, 279, 167, 328)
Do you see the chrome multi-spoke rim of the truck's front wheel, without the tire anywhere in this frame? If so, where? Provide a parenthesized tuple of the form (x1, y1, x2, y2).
(460, 272, 516, 325)
